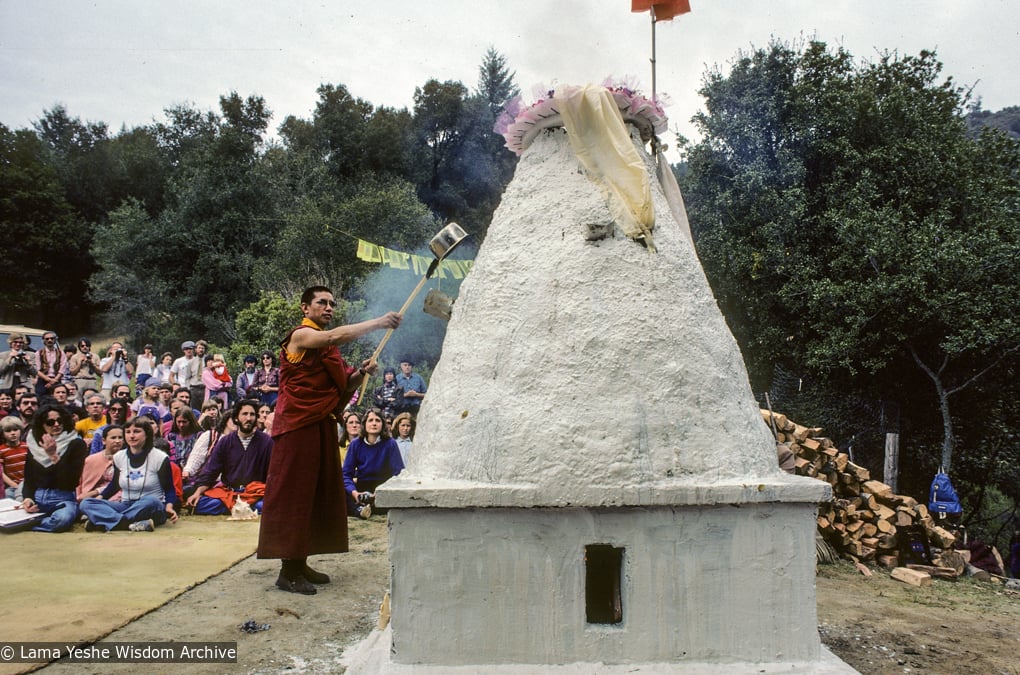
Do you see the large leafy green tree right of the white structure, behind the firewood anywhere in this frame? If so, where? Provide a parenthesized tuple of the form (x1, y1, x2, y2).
(684, 42, 1020, 475)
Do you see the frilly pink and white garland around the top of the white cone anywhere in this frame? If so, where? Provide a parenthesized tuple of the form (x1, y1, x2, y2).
(493, 79, 669, 155)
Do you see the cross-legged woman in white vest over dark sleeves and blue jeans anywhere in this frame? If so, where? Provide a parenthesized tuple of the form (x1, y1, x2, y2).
(82, 419, 180, 532)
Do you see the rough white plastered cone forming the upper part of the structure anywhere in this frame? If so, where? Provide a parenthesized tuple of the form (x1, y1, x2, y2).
(412, 124, 779, 505)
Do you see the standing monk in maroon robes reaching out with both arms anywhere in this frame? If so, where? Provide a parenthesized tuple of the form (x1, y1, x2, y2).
(258, 285, 401, 595)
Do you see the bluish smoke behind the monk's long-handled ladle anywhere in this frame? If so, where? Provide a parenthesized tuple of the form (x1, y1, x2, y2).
(349, 241, 477, 367)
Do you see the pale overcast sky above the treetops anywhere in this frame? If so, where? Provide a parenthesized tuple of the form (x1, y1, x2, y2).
(0, 0, 1020, 143)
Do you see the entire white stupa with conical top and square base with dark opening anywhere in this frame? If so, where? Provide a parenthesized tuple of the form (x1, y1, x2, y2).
(345, 84, 853, 674)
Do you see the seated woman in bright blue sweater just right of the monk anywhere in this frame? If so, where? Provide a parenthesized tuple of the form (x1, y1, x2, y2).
(344, 408, 404, 519)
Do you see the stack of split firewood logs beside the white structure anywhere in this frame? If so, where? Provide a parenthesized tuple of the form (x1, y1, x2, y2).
(762, 410, 956, 571)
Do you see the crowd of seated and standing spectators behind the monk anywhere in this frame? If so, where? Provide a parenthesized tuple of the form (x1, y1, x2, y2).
(0, 333, 425, 532)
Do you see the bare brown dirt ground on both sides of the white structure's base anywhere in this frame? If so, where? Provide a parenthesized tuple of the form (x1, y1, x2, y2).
(31, 517, 1020, 675)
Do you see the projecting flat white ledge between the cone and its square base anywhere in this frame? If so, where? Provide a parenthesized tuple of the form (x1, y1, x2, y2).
(375, 474, 832, 509)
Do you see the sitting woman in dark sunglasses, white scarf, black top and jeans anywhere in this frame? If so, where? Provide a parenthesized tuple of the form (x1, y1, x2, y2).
(21, 404, 89, 532)
